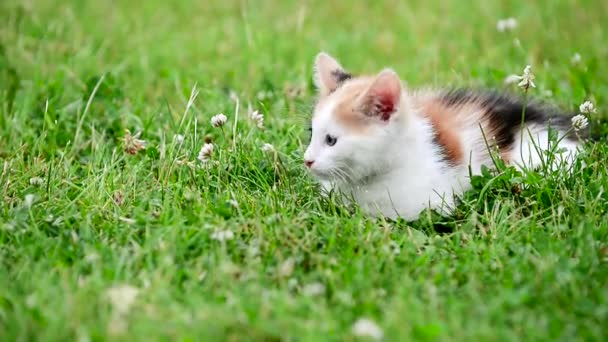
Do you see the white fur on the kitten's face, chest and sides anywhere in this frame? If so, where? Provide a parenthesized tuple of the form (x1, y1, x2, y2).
(304, 92, 577, 220)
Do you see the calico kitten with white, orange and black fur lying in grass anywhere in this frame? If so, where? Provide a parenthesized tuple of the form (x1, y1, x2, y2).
(304, 53, 580, 220)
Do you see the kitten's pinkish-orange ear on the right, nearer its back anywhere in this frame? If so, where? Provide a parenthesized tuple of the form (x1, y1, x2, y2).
(360, 69, 401, 121)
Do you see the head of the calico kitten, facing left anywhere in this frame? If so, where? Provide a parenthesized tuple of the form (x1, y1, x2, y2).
(304, 53, 403, 183)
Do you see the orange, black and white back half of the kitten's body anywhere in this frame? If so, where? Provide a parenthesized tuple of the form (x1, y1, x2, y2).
(414, 89, 579, 166)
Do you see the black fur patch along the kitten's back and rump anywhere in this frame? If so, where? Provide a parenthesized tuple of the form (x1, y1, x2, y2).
(441, 89, 573, 149)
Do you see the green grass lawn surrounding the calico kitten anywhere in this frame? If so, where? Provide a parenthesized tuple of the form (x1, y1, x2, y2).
(0, 0, 608, 341)
